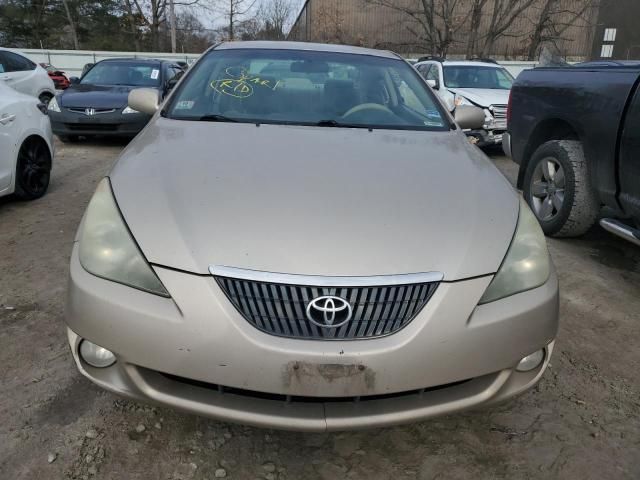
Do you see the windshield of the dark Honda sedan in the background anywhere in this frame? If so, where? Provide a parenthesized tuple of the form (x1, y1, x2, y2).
(80, 62, 160, 87)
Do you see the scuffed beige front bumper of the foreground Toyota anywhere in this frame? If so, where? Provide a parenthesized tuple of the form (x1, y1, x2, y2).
(66, 245, 558, 431)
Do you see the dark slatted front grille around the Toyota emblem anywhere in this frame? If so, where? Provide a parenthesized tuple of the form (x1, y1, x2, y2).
(215, 276, 439, 340)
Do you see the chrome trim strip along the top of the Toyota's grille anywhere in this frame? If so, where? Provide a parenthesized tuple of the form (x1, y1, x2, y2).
(209, 265, 444, 287)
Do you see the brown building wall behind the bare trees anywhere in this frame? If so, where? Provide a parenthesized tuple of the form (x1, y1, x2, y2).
(289, 0, 600, 60)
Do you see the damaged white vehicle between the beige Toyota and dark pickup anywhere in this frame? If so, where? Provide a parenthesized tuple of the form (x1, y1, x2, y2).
(414, 60, 514, 146)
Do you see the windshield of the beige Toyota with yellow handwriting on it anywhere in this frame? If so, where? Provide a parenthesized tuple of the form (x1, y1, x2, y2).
(164, 49, 449, 130)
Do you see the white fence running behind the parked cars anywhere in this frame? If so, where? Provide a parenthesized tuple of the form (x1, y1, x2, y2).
(15, 49, 537, 77)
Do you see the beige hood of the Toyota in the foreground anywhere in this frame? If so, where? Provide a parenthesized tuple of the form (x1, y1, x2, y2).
(110, 117, 518, 280)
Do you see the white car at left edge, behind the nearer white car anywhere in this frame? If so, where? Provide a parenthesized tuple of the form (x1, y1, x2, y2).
(0, 48, 56, 104)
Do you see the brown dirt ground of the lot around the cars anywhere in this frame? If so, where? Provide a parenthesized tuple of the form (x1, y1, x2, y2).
(0, 143, 640, 480)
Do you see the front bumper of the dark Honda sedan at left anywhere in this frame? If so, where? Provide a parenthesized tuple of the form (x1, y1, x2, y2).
(49, 107, 151, 137)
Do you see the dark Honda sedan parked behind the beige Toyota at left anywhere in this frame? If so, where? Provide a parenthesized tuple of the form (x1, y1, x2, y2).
(49, 59, 184, 142)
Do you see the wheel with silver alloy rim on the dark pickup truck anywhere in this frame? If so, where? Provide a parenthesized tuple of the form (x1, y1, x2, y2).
(524, 140, 600, 237)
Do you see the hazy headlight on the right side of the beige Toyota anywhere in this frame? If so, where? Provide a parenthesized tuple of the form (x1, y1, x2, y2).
(479, 197, 551, 304)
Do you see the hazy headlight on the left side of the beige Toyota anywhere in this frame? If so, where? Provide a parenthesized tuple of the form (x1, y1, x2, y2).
(79, 178, 169, 297)
